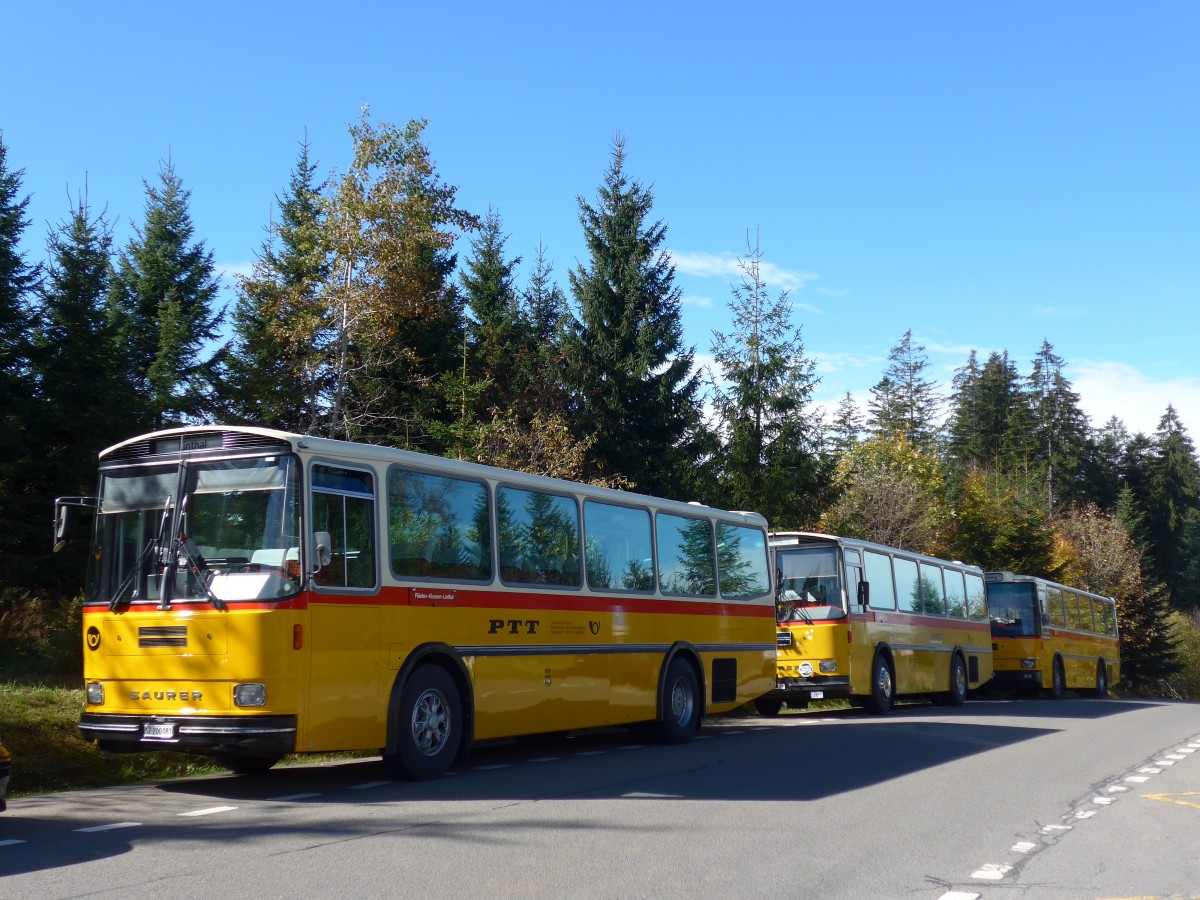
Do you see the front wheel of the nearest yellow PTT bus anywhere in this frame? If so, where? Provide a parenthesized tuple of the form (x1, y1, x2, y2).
(383, 665, 462, 781)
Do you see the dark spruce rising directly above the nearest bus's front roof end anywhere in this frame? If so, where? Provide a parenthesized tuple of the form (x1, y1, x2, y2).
(108, 158, 222, 428)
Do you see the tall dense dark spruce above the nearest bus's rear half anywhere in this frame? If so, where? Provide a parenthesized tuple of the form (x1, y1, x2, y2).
(564, 136, 700, 497)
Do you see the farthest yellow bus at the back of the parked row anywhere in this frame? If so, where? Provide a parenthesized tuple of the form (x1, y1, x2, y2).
(985, 572, 1121, 700)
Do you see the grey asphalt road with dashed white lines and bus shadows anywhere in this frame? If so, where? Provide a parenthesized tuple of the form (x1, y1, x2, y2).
(0, 700, 1200, 900)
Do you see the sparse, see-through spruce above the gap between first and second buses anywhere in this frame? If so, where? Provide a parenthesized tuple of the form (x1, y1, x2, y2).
(713, 234, 829, 527)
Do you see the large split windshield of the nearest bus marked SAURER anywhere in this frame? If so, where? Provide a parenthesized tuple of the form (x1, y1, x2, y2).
(88, 456, 300, 608)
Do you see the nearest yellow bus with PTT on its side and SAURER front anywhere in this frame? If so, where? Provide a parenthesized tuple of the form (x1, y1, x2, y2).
(68, 426, 775, 779)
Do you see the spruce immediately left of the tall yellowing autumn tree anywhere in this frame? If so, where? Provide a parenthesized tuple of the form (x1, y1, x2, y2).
(223, 142, 330, 433)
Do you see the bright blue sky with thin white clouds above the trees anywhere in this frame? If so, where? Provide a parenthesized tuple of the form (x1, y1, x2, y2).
(0, 0, 1200, 438)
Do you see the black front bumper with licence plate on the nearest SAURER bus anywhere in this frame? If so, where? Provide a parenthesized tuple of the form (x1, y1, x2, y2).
(79, 713, 296, 756)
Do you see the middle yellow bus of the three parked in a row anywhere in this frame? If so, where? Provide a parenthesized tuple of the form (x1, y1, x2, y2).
(755, 532, 992, 715)
